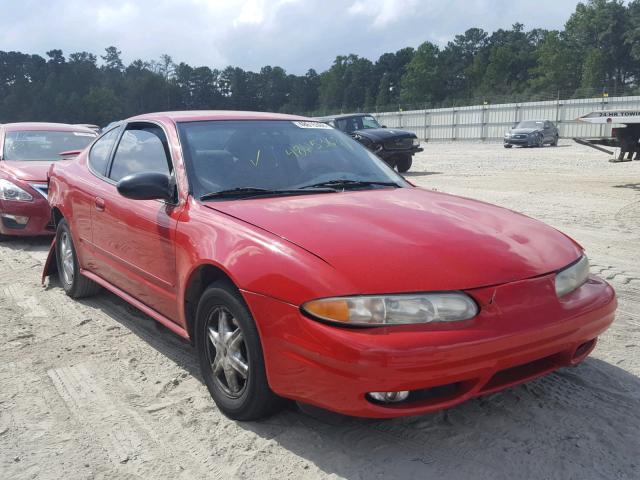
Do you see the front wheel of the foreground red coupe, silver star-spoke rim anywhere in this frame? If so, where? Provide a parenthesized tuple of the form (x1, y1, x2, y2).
(194, 282, 283, 421)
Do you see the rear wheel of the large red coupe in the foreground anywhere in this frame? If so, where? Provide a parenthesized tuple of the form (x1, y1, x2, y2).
(56, 218, 101, 298)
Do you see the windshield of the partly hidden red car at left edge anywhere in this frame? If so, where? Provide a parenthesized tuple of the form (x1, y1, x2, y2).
(3, 130, 96, 161)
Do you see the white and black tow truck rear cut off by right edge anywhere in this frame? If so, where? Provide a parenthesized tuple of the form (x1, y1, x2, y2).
(573, 110, 640, 163)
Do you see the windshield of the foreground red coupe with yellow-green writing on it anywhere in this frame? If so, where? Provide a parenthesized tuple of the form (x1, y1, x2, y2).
(178, 120, 408, 198)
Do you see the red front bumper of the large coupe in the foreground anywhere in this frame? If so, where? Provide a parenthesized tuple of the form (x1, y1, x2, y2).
(243, 275, 617, 418)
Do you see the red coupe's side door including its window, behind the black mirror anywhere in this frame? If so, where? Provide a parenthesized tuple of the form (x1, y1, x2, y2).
(91, 122, 180, 319)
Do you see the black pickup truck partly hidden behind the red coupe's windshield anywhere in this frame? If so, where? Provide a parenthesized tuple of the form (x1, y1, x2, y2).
(316, 113, 424, 172)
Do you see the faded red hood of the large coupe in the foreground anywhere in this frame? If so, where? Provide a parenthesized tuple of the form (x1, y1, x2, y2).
(205, 188, 582, 294)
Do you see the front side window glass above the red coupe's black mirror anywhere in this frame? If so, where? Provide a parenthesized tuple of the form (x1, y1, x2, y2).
(109, 124, 172, 182)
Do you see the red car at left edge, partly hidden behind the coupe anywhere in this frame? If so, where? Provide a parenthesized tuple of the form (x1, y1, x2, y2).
(0, 123, 96, 239)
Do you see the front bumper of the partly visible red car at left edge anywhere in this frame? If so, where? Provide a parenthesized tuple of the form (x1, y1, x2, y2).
(0, 194, 54, 237)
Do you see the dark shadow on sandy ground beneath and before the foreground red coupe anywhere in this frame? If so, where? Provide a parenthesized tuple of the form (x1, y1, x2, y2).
(51, 277, 640, 480)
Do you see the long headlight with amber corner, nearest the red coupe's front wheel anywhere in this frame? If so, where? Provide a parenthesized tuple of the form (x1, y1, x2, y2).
(301, 293, 478, 326)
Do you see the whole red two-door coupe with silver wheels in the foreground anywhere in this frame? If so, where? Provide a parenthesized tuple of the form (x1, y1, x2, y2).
(44, 112, 616, 420)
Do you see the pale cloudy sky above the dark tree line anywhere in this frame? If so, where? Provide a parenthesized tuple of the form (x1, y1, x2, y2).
(0, 0, 578, 74)
